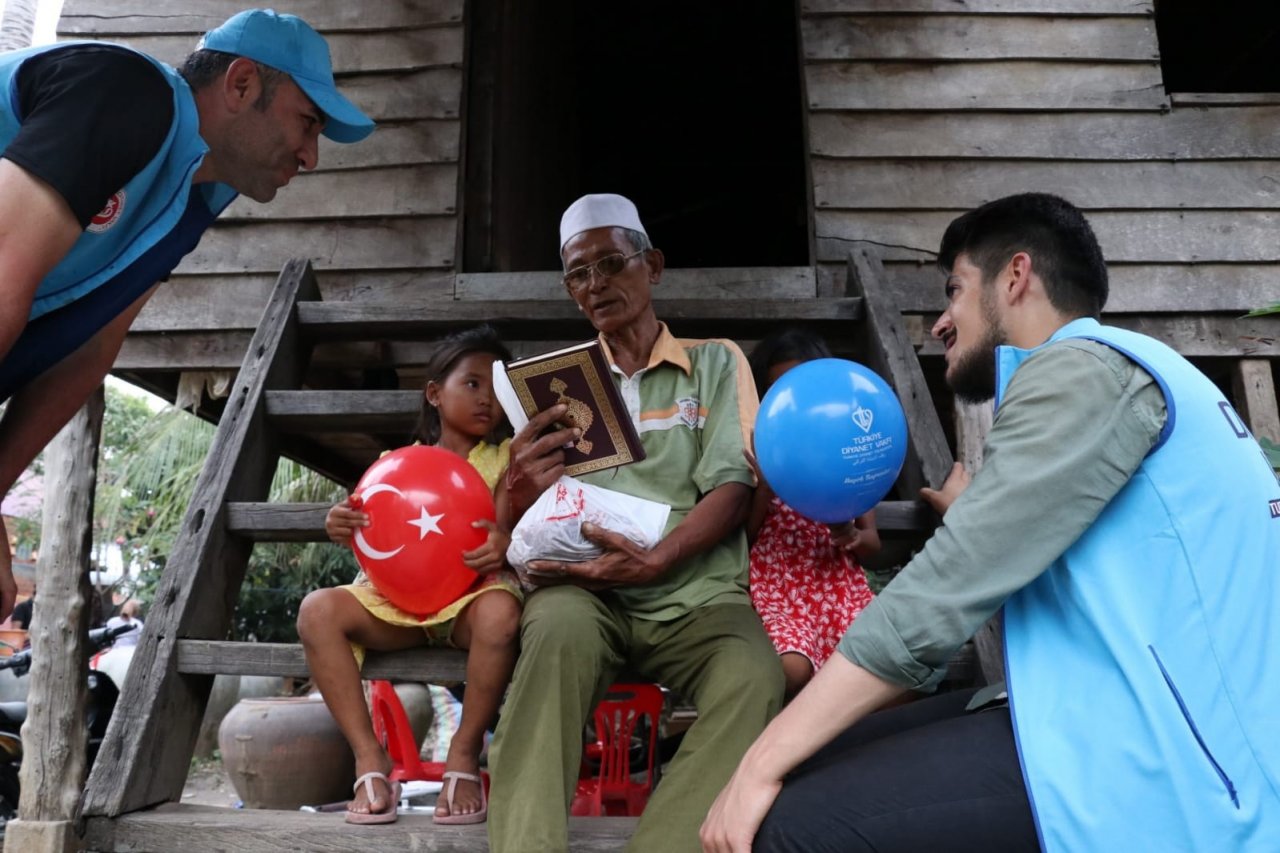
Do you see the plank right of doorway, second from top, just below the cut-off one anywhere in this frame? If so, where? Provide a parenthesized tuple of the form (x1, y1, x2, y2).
(800, 14, 1160, 61)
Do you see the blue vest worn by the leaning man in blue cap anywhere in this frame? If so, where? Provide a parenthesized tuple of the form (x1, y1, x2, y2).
(0, 42, 236, 320)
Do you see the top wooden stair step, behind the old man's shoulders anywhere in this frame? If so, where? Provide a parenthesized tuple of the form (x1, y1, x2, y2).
(297, 297, 863, 342)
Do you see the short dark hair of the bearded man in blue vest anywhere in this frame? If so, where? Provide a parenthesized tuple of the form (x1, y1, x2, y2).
(938, 192, 1107, 318)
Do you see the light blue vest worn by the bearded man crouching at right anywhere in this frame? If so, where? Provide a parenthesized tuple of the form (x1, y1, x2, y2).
(996, 319, 1280, 853)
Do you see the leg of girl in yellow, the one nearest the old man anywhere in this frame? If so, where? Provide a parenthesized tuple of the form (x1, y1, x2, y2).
(435, 589, 520, 817)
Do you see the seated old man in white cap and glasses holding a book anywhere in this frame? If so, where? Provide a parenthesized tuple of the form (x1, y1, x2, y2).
(489, 195, 782, 853)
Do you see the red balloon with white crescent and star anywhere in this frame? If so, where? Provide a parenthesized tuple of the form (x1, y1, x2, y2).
(351, 447, 497, 616)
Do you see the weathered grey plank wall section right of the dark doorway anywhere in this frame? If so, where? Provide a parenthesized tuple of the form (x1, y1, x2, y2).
(800, 0, 1280, 356)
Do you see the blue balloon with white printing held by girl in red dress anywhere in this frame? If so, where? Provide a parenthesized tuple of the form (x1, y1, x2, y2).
(755, 359, 906, 524)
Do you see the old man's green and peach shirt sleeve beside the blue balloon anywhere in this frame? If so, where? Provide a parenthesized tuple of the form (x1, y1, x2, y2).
(694, 341, 760, 494)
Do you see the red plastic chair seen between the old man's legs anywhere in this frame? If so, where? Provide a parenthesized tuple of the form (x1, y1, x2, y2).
(570, 684, 663, 817)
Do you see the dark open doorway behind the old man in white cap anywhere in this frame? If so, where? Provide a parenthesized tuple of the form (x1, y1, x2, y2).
(463, 0, 810, 273)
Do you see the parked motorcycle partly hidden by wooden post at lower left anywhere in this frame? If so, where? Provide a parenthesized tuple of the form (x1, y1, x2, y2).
(0, 625, 137, 826)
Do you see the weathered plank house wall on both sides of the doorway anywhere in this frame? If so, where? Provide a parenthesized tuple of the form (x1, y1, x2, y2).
(59, 0, 1280, 370)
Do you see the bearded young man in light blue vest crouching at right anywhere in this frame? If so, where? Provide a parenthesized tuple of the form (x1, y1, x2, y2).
(703, 193, 1280, 853)
